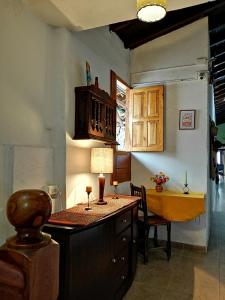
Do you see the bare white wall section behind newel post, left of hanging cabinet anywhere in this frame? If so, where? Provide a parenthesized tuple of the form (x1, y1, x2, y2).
(0, 0, 66, 241)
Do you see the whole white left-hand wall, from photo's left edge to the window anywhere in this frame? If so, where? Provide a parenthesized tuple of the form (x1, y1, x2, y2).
(0, 0, 130, 243)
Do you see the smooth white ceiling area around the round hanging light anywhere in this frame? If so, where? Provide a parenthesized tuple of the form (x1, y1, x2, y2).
(22, 0, 214, 31)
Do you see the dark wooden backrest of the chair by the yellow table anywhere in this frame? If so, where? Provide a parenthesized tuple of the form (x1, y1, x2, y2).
(130, 183, 148, 224)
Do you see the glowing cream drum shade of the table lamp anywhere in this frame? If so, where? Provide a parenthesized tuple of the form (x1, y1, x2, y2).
(91, 148, 113, 174)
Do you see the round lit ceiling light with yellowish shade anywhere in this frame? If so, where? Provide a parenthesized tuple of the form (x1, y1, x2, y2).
(137, 0, 167, 22)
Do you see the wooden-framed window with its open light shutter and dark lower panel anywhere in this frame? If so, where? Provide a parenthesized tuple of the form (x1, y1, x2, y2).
(111, 71, 164, 182)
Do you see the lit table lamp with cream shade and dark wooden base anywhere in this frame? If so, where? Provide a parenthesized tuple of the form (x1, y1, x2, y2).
(91, 148, 113, 205)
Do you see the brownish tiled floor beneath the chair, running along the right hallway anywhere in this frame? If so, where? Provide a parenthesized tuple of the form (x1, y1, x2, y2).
(123, 182, 225, 300)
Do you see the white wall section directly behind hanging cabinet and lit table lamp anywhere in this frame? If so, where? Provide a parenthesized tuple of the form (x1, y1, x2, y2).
(61, 27, 130, 207)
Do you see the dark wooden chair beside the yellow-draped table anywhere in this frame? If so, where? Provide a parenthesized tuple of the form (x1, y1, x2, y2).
(130, 183, 171, 264)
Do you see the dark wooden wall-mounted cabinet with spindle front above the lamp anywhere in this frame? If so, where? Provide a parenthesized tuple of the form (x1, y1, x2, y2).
(74, 85, 116, 142)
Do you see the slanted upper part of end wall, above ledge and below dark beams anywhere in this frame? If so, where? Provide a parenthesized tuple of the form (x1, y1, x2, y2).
(131, 18, 208, 74)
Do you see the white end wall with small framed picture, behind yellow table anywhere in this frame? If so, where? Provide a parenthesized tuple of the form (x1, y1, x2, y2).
(131, 19, 208, 246)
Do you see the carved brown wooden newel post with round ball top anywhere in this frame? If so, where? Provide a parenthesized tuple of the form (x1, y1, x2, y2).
(0, 190, 59, 300)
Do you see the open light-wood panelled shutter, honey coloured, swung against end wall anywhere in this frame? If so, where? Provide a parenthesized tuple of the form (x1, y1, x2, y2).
(129, 86, 164, 151)
